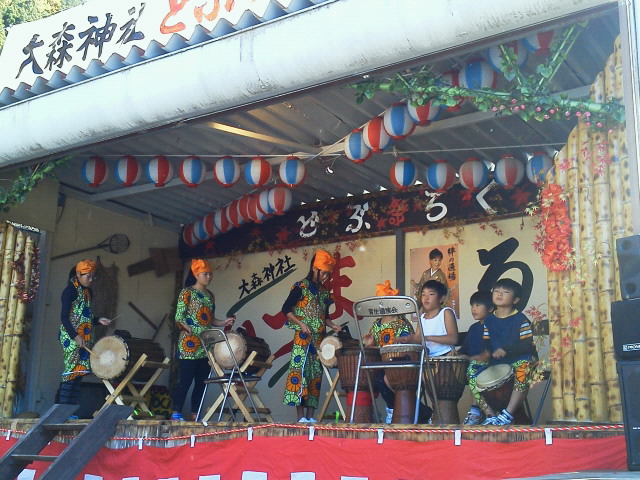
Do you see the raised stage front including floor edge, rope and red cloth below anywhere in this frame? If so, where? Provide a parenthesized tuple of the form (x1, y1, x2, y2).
(0, 419, 627, 480)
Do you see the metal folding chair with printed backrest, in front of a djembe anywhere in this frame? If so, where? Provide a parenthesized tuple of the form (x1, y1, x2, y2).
(349, 296, 442, 424)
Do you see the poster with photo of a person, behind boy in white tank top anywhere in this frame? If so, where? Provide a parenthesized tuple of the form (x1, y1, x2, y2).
(409, 243, 460, 318)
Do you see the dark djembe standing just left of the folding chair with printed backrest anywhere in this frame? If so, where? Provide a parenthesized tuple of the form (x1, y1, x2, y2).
(336, 346, 380, 423)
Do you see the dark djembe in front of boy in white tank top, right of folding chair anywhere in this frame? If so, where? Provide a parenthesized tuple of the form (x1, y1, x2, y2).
(426, 356, 469, 424)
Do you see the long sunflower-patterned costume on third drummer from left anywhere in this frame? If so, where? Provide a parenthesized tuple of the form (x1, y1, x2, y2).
(284, 279, 333, 408)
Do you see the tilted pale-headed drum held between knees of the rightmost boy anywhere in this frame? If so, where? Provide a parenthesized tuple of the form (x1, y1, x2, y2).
(476, 363, 531, 425)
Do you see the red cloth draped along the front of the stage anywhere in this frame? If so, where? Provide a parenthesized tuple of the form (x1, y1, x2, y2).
(0, 434, 627, 480)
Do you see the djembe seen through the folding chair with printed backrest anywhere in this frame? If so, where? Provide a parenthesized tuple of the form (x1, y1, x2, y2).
(380, 344, 422, 423)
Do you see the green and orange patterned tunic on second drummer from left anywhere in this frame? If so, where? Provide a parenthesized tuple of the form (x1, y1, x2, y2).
(175, 287, 215, 360)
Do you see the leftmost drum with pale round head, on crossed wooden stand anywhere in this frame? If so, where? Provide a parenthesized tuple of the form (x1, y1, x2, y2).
(91, 332, 165, 382)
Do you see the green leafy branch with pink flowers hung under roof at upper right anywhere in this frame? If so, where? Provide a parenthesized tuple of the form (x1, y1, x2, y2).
(351, 23, 625, 130)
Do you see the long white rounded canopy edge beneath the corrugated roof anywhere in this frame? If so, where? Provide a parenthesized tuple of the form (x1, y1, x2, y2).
(0, 0, 616, 167)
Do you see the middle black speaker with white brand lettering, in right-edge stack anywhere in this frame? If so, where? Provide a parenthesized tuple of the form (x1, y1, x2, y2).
(611, 298, 640, 360)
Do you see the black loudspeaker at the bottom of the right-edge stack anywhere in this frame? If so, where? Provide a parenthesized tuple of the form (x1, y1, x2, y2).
(618, 362, 640, 470)
